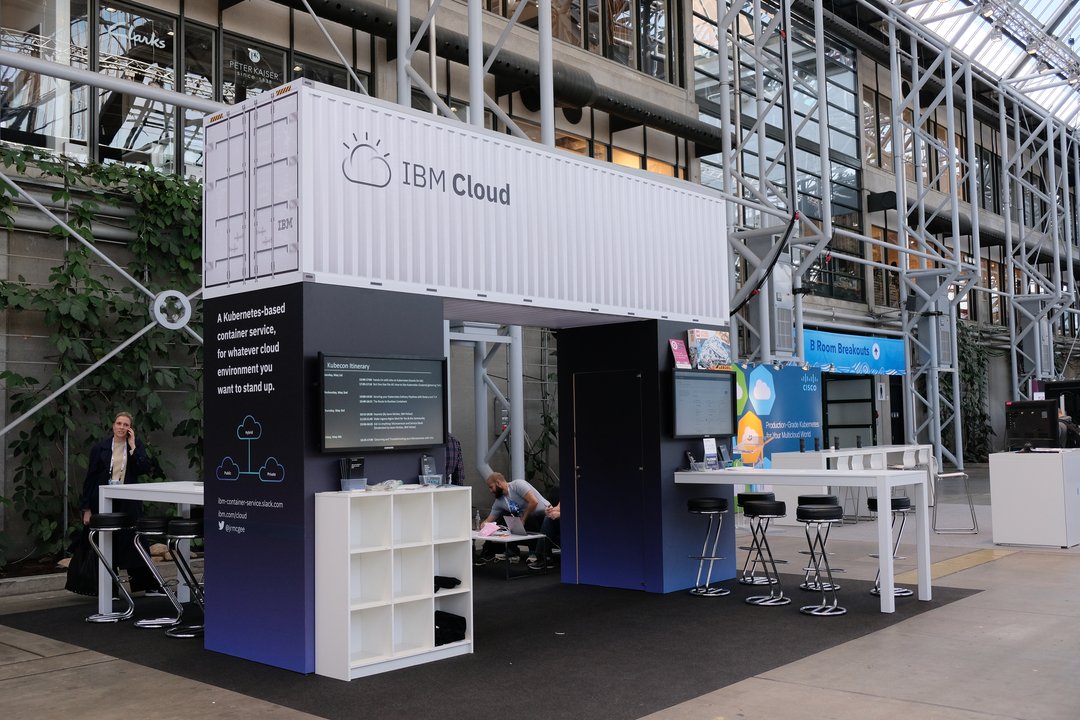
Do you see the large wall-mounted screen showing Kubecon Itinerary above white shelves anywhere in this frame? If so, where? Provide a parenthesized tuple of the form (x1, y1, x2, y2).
(319, 353, 446, 452)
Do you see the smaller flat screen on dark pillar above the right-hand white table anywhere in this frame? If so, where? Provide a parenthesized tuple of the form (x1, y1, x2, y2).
(672, 370, 735, 437)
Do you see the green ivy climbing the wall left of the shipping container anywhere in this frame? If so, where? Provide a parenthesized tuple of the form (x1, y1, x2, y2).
(0, 147, 202, 567)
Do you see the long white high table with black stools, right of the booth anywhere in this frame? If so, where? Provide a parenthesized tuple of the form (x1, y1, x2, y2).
(675, 467, 931, 612)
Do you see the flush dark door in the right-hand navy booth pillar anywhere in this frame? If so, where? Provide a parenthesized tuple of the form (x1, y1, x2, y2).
(573, 370, 646, 589)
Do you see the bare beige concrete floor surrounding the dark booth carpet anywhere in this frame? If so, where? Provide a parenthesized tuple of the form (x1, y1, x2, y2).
(0, 470, 1080, 720)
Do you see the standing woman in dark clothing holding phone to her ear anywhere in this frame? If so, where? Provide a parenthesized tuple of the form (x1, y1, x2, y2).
(79, 412, 159, 593)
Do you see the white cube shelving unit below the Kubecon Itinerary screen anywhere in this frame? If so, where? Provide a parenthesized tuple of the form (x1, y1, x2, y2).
(315, 486, 473, 680)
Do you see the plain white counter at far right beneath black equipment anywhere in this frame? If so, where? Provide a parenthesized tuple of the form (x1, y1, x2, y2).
(990, 450, 1080, 547)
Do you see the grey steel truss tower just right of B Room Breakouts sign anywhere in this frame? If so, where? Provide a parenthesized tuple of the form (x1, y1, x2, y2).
(888, 10, 981, 468)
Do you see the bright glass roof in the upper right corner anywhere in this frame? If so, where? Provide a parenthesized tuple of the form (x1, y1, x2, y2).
(901, 0, 1080, 127)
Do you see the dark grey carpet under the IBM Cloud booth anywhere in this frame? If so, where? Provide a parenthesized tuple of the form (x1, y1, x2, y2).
(0, 568, 973, 720)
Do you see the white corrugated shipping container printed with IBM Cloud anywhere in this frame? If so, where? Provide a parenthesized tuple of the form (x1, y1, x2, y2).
(204, 81, 728, 324)
